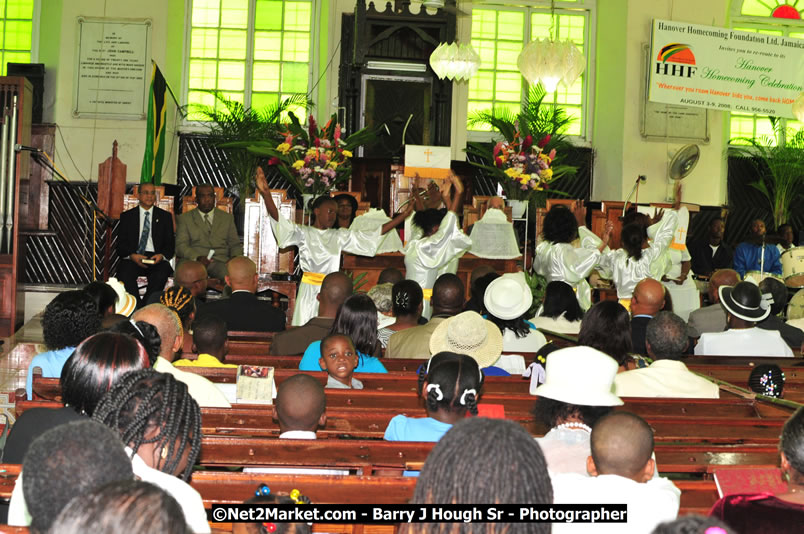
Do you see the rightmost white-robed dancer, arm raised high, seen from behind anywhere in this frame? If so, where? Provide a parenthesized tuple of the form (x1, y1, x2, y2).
(599, 211, 678, 308)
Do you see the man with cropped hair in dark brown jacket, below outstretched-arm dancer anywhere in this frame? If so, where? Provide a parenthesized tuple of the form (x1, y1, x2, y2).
(271, 272, 352, 356)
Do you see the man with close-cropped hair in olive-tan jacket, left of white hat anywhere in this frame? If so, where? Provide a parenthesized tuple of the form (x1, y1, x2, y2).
(385, 273, 465, 359)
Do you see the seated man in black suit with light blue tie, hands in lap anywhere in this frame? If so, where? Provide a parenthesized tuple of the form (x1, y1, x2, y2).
(117, 184, 175, 304)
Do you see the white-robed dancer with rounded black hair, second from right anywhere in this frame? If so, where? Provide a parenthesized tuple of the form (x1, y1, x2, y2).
(533, 204, 612, 311)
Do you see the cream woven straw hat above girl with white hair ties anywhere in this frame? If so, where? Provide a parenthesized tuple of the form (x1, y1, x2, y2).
(430, 311, 502, 368)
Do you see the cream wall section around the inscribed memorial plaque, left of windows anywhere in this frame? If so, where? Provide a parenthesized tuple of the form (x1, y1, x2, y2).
(42, 0, 178, 183)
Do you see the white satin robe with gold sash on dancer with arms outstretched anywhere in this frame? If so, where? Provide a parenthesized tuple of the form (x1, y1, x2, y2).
(270, 214, 382, 326)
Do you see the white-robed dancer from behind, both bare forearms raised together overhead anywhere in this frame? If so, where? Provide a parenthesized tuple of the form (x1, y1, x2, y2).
(405, 173, 472, 319)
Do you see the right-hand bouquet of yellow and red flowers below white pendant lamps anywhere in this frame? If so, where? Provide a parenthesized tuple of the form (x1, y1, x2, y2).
(492, 132, 556, 200)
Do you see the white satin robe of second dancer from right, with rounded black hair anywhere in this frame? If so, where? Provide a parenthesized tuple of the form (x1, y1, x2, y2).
(533, 226, 602, 311)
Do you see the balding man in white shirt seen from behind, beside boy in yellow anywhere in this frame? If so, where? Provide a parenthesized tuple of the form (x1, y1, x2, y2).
(131, 304, 230, 408)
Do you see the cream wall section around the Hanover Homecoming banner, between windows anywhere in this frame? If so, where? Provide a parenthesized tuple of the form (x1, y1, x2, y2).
(592, 0, 729, 205)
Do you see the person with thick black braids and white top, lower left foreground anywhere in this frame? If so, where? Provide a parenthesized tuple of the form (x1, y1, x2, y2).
(92, 369, 210, 532)
